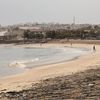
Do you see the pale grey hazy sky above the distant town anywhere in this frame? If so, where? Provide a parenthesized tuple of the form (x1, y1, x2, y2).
(0, 0, 100, 25)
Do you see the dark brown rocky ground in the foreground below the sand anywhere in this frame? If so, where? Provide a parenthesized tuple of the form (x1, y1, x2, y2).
(0, 69, 100, 100)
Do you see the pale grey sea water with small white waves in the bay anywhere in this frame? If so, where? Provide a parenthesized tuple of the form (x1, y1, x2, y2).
(0, 46, 88, 78)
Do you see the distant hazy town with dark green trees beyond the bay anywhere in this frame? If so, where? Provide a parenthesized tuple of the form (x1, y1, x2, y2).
(0, 23, 100, 43)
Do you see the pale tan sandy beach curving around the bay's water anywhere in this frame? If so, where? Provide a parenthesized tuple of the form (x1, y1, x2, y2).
(0, 43, 100, 92)
